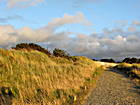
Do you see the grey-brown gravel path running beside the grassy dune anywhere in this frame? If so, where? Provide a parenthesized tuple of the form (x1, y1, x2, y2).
(84, 70, 140, 105)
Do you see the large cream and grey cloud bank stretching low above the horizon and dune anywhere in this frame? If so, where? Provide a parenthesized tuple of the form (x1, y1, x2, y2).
(0, 13, 140, 58)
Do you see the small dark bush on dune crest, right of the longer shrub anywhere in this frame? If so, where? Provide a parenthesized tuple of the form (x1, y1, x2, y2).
(53, 48, 70, 58)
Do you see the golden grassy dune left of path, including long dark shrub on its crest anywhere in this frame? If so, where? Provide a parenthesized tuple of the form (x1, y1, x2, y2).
(0, 44, 103, 105)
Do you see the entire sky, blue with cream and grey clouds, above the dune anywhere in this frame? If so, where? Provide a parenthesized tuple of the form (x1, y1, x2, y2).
(0, 0, 140, 59)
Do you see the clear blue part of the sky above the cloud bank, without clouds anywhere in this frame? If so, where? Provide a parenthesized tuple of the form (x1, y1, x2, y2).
(0, 0, 140, 32)
